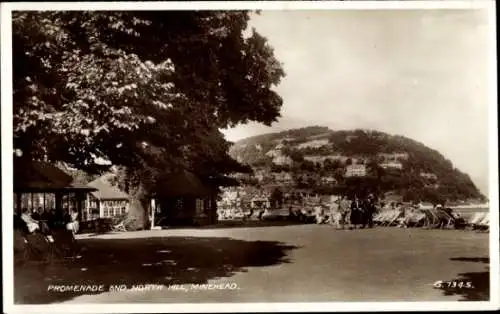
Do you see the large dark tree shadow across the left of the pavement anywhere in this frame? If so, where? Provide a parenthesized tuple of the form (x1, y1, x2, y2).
(14, 237, 297, 304)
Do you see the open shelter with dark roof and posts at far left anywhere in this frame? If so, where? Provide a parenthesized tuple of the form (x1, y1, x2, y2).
(14, 157, 95, 219)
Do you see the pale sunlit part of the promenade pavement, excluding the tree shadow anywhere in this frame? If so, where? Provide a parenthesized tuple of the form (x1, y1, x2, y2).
(66, 225, 488, 302)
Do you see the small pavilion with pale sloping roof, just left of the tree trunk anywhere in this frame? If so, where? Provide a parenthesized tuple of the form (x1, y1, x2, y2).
(83, 174, 130, 220)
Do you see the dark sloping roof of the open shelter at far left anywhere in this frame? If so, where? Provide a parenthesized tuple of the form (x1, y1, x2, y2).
(14, 158, 97, 193)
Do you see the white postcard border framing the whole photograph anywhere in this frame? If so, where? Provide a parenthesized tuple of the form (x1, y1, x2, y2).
(0, 0, 500, 313)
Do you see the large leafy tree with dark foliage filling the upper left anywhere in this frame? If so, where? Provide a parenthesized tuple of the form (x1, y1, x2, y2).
(13, 11, 284, 227)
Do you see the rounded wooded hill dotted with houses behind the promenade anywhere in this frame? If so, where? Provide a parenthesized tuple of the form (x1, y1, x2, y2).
(230, 126, 485, 203)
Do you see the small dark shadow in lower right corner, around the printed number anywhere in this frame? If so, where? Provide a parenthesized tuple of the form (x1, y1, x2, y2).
(440, 257, 490, 301)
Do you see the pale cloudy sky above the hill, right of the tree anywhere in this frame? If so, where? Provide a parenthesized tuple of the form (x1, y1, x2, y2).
(224, 10, 490, 195)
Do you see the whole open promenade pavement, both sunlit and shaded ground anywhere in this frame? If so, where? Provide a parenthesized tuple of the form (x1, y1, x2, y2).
(14, 225, 488, 303)
